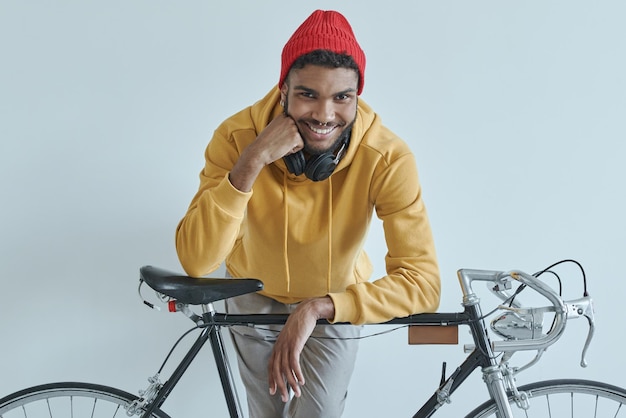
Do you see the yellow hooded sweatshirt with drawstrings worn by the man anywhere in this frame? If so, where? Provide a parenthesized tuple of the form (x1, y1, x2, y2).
(176, 87, 440, 324)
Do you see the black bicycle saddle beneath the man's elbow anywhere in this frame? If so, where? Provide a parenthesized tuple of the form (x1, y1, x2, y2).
(139, 266, 263, 305)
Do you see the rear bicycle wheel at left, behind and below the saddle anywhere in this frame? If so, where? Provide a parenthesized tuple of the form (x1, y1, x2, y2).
(0, 382, 170, 418)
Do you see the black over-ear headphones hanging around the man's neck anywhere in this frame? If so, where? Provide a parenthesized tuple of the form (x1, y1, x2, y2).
(283, 132, 350, 181)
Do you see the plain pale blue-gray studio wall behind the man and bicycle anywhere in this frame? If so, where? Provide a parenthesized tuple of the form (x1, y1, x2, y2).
(0, 0, 626, 417)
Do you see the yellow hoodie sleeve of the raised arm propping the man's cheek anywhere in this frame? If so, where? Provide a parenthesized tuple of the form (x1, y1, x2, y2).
(176, 125, 255, 277)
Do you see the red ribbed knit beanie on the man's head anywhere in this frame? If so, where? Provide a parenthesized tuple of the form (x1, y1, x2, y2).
(278, 10, 365, 94)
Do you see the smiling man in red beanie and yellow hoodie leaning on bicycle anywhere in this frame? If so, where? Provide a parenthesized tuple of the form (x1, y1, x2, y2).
(176, 10, 440, 417)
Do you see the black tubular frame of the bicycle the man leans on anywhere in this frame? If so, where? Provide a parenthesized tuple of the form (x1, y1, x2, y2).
(142, 306, 491, 418)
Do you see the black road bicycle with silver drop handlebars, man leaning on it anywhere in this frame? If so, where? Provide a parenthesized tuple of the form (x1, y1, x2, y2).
(0, 260, 626, 418)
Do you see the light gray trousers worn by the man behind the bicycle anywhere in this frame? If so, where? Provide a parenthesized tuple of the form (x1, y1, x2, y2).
(226, 293, 361, 418)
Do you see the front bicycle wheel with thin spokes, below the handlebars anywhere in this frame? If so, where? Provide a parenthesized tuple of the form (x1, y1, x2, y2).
(466, 379, 626, 418)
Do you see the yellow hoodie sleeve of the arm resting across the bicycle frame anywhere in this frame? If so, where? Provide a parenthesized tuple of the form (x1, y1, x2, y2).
(330, 149, 441, 324)
